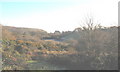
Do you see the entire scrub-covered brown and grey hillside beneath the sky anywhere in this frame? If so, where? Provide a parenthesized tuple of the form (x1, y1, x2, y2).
(1, 26, 118, 70)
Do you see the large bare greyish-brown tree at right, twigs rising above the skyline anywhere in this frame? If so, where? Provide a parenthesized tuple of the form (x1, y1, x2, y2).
(77, 17, 118, 69)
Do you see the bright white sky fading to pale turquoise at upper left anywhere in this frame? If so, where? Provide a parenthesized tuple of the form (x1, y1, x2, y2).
(0, 0, 119, 32)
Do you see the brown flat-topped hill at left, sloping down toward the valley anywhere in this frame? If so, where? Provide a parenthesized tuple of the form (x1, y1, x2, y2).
(2, 26, 48, 41)
